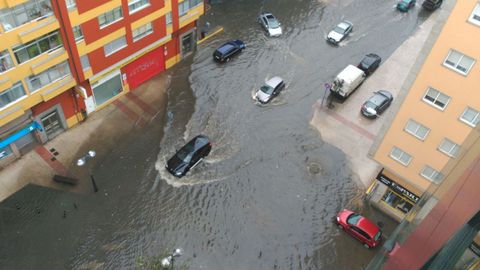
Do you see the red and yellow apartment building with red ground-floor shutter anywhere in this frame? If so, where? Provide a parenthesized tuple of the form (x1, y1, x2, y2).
(0, 0, 204, 167)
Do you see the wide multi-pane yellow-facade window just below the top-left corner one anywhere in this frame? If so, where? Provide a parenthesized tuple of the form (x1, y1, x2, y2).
(13, 31, 62, 64)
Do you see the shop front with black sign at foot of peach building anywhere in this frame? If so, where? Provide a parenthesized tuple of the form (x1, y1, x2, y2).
(367, 169, 420, 221)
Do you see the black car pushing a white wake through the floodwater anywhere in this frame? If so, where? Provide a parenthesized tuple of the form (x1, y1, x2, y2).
(165, 135, 212, 178)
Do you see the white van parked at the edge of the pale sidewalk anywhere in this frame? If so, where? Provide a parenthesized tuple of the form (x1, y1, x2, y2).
(330, 65, 366, 98)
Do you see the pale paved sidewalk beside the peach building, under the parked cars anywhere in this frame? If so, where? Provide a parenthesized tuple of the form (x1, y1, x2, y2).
(310, 12, 438, 187)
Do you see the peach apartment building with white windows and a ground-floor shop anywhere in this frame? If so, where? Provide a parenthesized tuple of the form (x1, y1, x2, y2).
(367, 0, 480, 220)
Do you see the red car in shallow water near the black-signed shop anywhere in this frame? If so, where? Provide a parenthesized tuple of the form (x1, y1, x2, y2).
(337, 209, 382, 248)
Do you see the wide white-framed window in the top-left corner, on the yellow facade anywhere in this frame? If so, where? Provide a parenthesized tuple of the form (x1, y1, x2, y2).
(0, 0, 53, 31)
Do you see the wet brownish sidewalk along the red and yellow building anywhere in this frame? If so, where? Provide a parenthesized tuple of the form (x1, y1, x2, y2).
(0, 71, 170, 202)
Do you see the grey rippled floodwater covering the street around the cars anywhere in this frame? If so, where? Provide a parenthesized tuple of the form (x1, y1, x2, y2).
(0, 0, 426, 270)
